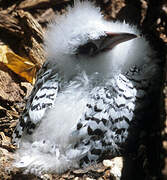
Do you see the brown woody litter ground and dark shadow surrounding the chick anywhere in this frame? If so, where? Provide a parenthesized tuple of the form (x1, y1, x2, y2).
(0, 0, 167, 180)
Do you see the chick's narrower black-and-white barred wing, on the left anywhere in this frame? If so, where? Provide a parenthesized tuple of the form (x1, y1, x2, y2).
(12, 62, 59, 144)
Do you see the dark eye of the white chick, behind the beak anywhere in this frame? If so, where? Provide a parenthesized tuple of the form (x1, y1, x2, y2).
(77, 42, 97, 56)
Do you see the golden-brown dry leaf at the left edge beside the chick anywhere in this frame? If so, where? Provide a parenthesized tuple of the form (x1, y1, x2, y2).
(0, 46, 37, 84)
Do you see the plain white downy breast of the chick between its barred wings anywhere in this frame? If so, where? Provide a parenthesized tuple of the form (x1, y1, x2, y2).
(34, 83, 88, 146)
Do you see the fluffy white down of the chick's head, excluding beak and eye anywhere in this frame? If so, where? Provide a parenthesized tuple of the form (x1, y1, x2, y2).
(45, 1, 153, 77)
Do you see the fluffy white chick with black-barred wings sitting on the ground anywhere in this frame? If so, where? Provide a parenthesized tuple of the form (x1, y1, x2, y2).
(12, 0, 159, 175)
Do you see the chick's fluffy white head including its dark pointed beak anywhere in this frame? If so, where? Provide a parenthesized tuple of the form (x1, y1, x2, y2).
(45, 1, 150, 79)
